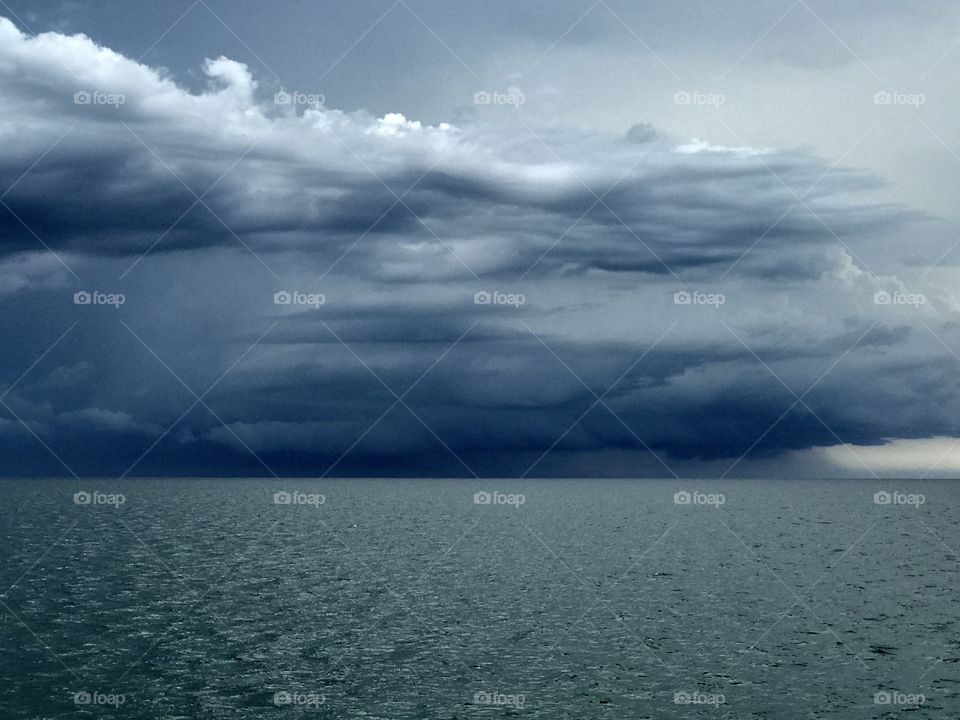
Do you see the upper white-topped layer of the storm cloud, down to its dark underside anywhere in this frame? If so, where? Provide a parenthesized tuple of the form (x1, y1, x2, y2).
(0, 18, 904, 279)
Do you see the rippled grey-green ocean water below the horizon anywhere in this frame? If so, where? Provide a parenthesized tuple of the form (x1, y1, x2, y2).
(0, 479, 960, 720)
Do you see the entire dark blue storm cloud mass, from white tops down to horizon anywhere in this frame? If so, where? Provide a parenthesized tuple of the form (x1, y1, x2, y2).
(0, 14, 960, 475)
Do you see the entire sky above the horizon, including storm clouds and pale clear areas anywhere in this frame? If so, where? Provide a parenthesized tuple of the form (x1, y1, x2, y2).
(0, 0, 960, 478)
